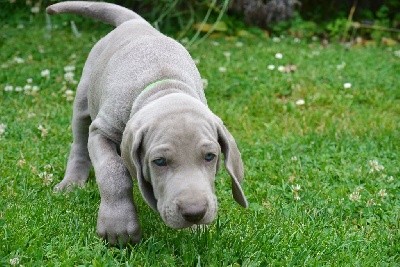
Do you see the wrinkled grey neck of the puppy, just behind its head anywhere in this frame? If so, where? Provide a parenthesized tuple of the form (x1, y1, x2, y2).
(130, 79, 207, 118)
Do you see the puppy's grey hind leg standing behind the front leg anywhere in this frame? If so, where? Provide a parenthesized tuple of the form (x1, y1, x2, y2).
(54, 80, 91, 191)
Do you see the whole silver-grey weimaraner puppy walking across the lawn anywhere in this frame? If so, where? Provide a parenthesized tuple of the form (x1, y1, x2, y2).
(47, 1, 248, 244)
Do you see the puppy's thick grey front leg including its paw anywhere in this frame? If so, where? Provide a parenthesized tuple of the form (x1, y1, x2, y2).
(88, 127, 141, 245)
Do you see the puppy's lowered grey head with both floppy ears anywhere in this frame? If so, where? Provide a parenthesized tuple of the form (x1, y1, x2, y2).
(121, 94, 247, 228)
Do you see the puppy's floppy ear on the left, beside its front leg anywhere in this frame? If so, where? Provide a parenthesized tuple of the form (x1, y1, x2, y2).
(121, 122, 157, 211)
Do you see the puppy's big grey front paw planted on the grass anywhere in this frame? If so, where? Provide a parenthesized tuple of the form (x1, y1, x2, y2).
(97, 201, 141, 245)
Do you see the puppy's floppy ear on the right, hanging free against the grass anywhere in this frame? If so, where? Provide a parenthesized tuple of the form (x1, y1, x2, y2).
(217, 118, 248, 208)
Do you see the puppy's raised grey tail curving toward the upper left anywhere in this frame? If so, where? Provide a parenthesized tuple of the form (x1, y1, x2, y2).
(46, 1, 144, 27)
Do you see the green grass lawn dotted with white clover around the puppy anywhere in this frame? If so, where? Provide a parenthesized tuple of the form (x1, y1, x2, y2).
(0, 11, 400, 266)
